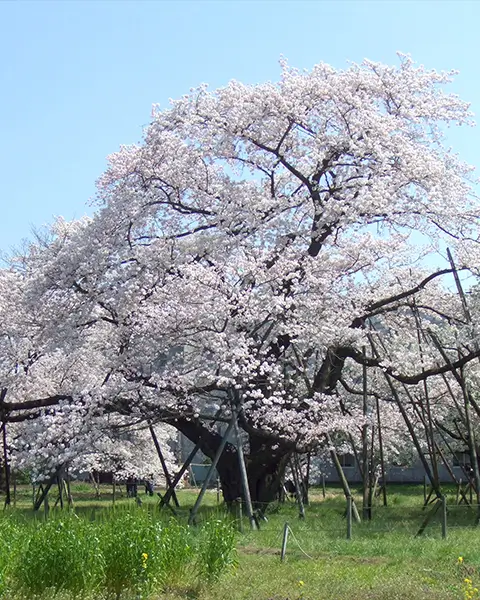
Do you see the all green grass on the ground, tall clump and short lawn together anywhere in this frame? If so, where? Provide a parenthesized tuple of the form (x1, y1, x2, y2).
(0, 485, 480, 600)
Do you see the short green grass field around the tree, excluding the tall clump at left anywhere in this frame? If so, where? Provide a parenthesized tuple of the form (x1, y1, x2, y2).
(0, 484, 480, 600)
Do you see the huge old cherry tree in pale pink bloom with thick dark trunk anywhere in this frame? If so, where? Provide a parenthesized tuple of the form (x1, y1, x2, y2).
(3, 56, 479, 503)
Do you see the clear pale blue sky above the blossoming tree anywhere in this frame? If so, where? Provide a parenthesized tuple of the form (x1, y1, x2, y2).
(0, 0, 480, 252)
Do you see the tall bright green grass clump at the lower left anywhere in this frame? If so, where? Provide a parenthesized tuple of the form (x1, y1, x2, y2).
(0, 510, 235, 600)
